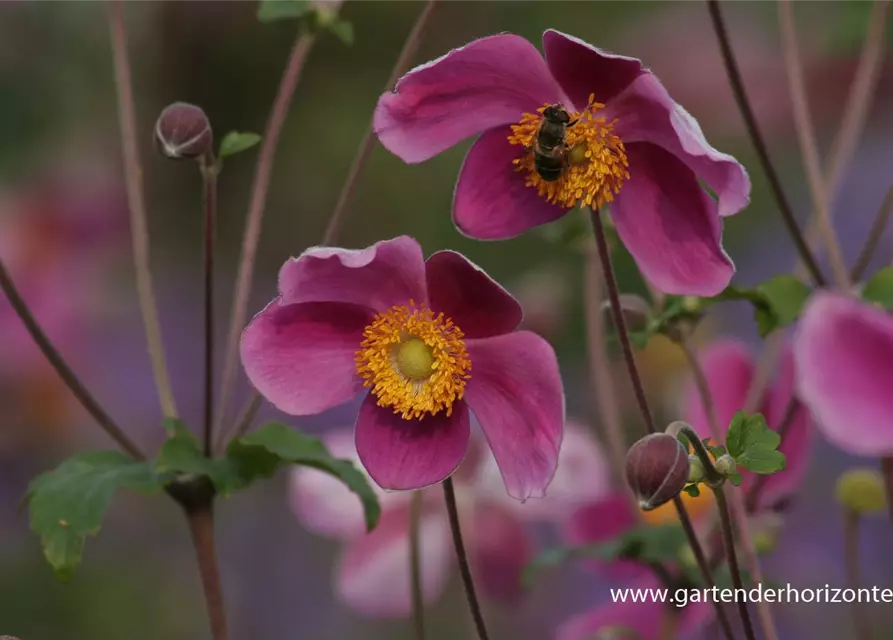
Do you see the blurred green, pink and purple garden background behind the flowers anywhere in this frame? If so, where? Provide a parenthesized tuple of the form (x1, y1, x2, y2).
(0, 0, 893, 640)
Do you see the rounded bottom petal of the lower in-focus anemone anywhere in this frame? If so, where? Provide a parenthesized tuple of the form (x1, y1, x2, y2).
(356, 393, 471, 490)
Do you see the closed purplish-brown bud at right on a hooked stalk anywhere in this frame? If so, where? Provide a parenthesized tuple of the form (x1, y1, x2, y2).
(626, 433, 690, 511)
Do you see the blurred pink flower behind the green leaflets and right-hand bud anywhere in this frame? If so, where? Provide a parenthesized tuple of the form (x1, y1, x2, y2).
(682, 339, 812, 508)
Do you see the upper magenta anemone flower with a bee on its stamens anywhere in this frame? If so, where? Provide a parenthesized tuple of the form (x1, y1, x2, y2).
(374, 30, 750, 296)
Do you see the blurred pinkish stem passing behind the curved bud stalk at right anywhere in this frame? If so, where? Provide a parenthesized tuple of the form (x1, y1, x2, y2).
(679, 335, 778, 640)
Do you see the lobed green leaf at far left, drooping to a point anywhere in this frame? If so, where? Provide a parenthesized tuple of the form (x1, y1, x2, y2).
(25, 451, 161, 582)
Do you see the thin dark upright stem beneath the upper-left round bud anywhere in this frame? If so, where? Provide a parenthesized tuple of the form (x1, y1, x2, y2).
(201, 158, 217, 457)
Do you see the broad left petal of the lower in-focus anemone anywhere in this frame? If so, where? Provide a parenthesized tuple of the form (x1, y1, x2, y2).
(240, 298, 371, 416)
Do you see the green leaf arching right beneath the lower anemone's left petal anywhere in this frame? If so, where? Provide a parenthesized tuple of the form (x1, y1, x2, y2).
(227, 422, 381, 531)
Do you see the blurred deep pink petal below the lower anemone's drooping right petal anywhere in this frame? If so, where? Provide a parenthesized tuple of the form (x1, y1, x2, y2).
(468, 503, 533, 602)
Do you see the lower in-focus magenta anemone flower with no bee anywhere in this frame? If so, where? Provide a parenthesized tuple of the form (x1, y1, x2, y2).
(241, 236, 564, 500)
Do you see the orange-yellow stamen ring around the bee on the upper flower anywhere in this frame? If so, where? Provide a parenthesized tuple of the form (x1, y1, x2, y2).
(508, 95, 629, 209)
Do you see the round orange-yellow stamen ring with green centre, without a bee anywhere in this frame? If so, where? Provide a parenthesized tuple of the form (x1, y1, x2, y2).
(356, 300, 471, 420)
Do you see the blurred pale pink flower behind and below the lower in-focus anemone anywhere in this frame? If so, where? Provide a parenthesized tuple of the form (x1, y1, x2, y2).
(290, 423, 608, 618)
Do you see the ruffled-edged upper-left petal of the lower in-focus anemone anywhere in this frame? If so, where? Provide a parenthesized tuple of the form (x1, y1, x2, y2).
(279, 236, 428, 312)
